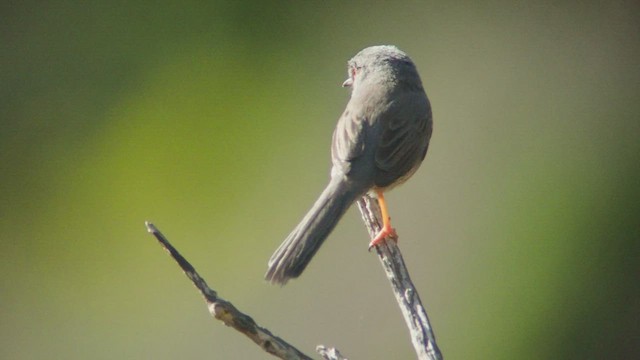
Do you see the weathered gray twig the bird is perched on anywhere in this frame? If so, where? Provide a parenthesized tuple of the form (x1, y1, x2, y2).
(358, 195, 442, 360)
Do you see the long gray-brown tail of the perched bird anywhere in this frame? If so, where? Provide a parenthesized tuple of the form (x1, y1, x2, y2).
(265, 179, 364, 285)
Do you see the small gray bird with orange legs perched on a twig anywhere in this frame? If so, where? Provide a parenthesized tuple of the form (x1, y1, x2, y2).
(265, 46, 433, 285)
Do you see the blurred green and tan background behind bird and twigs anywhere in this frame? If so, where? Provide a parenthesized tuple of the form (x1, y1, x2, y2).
(0, 1, 640, 359)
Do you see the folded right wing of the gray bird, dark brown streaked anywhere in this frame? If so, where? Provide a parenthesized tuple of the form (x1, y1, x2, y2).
(375, 91, 433, 187)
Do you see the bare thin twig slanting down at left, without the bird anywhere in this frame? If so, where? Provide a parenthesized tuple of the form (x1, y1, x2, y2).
(145, 222, 311, 360)
